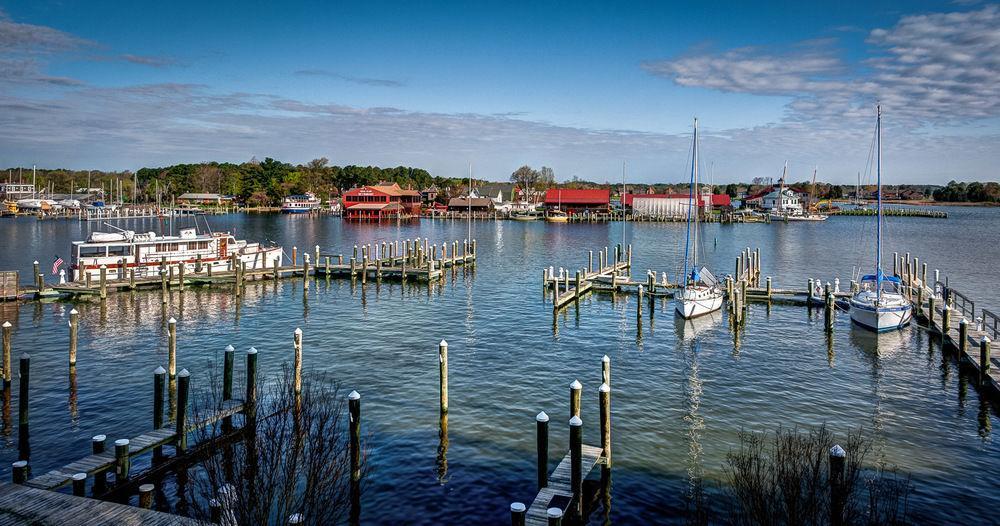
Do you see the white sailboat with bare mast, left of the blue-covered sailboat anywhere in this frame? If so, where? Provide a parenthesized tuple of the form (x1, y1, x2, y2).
(674, 119, 722, 318)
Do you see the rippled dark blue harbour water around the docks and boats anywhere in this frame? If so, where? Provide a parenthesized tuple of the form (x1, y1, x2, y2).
(0, 208, 1000, 524)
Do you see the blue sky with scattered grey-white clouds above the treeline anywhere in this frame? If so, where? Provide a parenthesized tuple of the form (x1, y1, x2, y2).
(0, 0, 1000, 184)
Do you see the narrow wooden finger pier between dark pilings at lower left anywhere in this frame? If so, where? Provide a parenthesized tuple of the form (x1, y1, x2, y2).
(25, 400, 243, 490)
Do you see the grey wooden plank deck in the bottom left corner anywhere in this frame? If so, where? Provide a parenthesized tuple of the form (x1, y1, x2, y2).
(0, 484, 202, 526)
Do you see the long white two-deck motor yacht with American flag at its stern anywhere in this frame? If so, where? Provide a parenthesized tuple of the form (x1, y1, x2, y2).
(70, 228, 282, 281)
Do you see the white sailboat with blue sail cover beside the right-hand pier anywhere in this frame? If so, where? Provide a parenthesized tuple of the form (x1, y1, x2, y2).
(850, 105, 913, 332)
